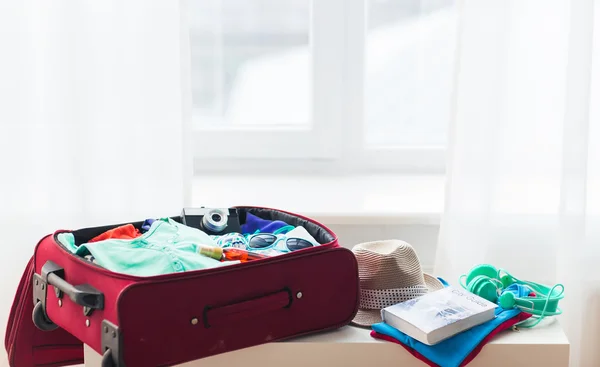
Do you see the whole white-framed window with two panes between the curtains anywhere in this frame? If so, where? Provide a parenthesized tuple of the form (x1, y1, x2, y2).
(186, 0, 456, 172)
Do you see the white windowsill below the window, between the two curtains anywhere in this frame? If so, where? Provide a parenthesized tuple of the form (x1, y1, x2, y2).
(192, 174, 445, 225)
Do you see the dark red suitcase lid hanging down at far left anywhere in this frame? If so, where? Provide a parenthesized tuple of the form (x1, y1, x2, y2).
(4, 258, 83, 367)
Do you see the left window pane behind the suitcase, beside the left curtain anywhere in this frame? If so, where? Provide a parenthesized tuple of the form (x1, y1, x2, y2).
(191, 0, 312, 128)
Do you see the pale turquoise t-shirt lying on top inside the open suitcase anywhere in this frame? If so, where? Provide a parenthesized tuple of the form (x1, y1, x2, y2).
(58, 218, 233, 276)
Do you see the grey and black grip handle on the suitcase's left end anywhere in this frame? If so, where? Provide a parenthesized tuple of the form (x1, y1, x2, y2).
(42, 261, 104, 310)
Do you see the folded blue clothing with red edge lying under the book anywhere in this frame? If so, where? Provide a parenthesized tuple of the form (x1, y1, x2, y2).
(371, 307, 531, 367)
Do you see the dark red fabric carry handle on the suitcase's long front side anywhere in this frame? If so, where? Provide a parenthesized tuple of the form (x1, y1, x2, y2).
(204, 288, 293, 328)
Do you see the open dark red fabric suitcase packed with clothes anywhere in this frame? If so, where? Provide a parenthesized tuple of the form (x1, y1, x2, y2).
(5, 207, 359, 367)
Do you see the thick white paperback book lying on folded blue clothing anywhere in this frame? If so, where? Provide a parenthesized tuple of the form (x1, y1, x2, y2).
(381, 286, 497, 345)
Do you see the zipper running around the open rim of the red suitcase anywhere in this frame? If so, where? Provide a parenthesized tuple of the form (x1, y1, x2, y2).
(52, 206, 339, 280)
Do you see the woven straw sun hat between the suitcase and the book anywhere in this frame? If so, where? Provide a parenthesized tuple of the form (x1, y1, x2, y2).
(352, 240, 444, 326)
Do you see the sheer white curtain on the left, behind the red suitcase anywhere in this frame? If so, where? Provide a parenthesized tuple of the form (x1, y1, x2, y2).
(0, 0, 189, 365)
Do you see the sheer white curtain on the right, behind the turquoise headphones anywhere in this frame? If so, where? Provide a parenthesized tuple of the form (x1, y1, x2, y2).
(436, 0, 600, 366)
